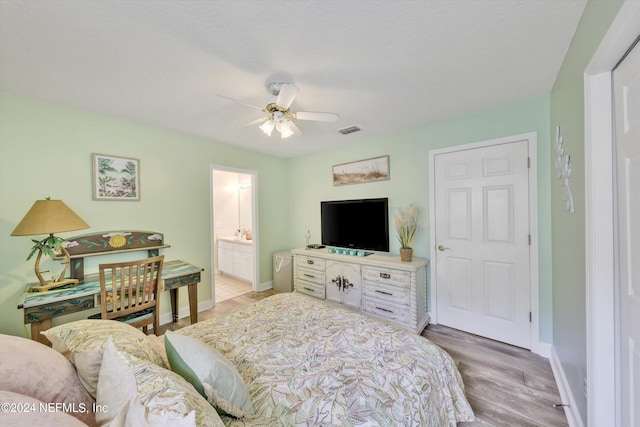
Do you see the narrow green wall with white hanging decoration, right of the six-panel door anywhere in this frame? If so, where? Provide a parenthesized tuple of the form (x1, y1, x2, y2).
(550, 0, 623, 425)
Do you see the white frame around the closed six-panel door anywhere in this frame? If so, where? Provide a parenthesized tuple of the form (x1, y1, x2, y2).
(429, 132, 550, 357)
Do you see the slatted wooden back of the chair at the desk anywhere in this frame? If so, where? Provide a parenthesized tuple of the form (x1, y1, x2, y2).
(98, 255, 164, 334)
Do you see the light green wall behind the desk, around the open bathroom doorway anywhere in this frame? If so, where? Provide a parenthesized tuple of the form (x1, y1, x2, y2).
(0, 94, 289, 335)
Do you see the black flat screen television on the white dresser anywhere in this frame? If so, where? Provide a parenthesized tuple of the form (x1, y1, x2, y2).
(320, 198, 389, 252)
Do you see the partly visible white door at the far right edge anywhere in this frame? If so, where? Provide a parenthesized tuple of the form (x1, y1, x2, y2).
(613, 38, 640, 427)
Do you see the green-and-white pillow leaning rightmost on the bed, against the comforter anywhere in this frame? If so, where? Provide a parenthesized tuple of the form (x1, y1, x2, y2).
(164, 331, 255, 418)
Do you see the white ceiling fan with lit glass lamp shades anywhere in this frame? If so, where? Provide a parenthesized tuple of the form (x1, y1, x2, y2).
(218, 82, 340, 139)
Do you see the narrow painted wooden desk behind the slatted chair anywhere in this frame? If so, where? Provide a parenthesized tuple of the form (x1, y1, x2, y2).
(18, 260, 203, 345)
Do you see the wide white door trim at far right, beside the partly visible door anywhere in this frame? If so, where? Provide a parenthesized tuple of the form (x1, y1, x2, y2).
(584, 0, 640, 427)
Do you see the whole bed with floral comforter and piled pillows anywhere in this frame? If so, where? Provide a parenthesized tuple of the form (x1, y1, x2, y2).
(0, 292, 474, 427)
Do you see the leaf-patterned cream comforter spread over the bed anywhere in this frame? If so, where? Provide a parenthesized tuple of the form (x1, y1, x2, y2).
(177, 292, 474, 427)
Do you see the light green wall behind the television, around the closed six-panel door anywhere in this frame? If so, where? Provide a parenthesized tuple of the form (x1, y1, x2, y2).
(289, 96, 553, 343)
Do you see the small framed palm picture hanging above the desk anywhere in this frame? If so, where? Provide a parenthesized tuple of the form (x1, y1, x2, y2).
(93, 153, 140, 201)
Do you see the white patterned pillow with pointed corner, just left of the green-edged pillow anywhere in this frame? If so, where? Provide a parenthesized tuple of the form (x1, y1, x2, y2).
(96, 339, 224, 427)
